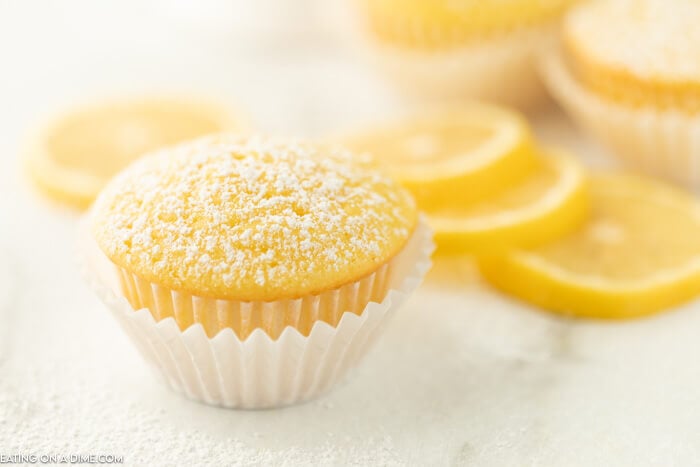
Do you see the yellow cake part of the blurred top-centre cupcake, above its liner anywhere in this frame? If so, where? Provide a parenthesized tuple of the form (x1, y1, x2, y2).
(358, 0, 576, 48)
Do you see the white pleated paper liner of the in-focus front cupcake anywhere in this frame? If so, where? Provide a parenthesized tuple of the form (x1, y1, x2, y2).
(81, 221, 434, 409)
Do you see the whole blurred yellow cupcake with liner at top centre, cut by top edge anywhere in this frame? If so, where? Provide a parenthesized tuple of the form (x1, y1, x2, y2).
(356, 0, 574, 107)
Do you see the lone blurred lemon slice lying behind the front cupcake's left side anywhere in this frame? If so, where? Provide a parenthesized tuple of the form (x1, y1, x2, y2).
(26, 98, 238, 208)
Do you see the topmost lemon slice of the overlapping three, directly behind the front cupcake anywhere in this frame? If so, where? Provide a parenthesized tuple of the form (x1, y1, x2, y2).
(339, 105, 536, 208)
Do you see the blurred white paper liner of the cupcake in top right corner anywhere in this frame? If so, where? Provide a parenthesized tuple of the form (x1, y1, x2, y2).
(541, 50, 700, 189)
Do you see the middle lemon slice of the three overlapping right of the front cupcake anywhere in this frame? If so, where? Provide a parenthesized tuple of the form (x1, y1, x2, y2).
(427, 150, 588, 254)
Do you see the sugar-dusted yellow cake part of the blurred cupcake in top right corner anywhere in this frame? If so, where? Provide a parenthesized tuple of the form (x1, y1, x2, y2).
(563, 0, 700, 110)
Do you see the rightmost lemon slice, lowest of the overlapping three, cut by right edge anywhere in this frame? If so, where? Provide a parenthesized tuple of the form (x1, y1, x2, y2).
(480, 175, 700, 318)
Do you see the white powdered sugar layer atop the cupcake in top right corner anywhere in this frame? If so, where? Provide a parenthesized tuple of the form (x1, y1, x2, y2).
(565, 0, 700, 81)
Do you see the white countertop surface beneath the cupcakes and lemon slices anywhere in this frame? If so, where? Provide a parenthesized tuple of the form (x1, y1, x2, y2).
(0, 0, 700, 466)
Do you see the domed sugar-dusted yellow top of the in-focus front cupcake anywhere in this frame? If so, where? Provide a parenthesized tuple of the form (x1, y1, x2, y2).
(92, 134, 417, 301)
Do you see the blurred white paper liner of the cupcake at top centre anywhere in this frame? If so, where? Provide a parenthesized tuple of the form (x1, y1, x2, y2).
(368, 24, 556, 108)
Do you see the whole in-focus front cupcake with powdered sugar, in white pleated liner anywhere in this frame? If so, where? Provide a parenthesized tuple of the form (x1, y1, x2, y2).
(82, 134, 432, 408)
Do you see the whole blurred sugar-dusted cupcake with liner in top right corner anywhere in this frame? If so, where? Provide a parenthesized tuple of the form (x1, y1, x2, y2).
(543, 0, 700, 187)
